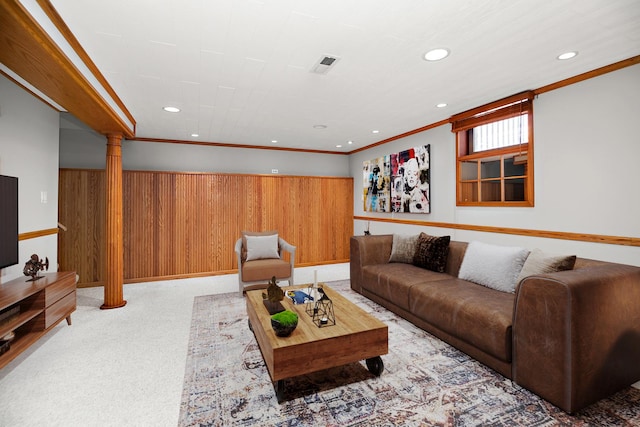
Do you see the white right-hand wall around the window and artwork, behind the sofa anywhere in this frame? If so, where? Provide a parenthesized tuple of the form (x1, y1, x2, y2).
(350, 65, 640, 265)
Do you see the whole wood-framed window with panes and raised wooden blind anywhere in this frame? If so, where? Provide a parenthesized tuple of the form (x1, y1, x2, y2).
(451, 92, 534, 206)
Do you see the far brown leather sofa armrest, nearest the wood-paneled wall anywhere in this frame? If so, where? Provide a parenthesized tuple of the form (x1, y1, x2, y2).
(349, 234, 393, 293)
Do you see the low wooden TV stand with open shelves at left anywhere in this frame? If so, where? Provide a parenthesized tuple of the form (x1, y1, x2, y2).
(0, 271, 76, 369)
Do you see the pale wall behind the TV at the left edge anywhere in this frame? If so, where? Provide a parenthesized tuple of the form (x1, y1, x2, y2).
(0, 75, 59, 283)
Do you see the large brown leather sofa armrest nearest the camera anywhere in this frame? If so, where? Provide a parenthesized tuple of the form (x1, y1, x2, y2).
(512, 263, 640, 413)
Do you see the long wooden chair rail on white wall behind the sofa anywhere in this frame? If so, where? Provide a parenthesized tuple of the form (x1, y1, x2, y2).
(353, 216, 640, 246)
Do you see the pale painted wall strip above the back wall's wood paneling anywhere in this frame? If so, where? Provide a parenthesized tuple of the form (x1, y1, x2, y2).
(60, 129, 349, 176)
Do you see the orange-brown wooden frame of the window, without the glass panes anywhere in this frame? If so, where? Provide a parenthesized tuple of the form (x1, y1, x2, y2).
(450, 91, 535, 207)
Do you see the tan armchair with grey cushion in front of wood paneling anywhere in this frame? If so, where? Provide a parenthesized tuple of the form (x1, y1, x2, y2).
(235, 231, 296, 296)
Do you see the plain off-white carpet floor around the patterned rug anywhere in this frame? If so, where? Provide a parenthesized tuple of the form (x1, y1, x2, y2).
(0, 263, 349, 427)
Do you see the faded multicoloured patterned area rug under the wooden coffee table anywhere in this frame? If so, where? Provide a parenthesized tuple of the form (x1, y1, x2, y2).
(179, 281, 640, 426)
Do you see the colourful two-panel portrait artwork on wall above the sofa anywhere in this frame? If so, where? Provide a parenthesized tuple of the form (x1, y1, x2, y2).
(362, 145, 431, 213)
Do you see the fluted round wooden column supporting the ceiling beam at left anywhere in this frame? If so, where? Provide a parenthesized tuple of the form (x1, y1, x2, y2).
(100, 134, 127, 310)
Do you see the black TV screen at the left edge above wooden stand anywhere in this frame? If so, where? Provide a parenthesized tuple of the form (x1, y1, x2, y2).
(0, 175, 18, 268)
